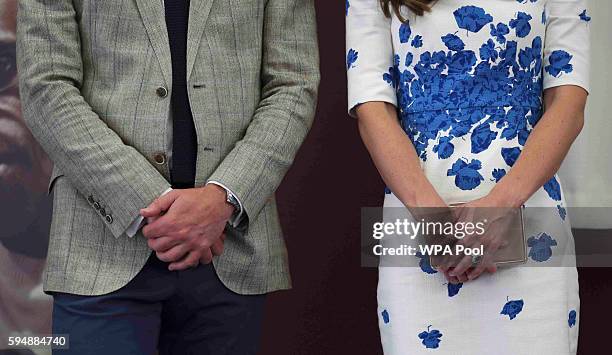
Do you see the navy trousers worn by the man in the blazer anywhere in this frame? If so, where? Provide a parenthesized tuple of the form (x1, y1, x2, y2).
(53, 254, 265, 355)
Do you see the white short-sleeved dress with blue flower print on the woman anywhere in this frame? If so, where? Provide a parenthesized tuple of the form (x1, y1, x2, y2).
(346, 0, 591, 355)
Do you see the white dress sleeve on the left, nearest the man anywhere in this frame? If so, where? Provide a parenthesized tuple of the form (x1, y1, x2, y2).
(346, 0, 397, 116)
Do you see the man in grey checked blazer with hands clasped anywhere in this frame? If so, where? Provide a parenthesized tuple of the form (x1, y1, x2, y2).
(17, 0, 319, 355)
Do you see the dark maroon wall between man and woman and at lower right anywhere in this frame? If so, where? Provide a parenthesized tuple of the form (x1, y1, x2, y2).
(261, 0, 612, 355)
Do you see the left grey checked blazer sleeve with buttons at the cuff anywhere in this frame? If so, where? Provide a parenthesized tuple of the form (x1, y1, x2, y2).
(17, 0, 170, 241)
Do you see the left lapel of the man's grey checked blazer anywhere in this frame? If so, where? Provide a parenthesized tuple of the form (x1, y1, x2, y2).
(136, 0, 172, 85)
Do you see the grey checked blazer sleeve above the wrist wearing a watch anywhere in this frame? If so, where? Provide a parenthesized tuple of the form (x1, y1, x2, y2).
(209, 0, 320, 230)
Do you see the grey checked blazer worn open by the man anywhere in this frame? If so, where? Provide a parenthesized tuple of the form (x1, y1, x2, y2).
(17, 0, 319, 295)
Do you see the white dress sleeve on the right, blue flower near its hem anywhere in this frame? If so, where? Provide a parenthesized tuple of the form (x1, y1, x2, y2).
(544, 0, 591, 91)
